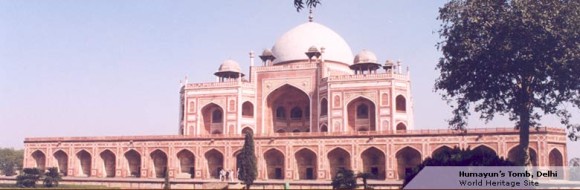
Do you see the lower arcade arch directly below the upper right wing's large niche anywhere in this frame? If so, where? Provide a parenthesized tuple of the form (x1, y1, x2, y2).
(361, 147, 387, 180)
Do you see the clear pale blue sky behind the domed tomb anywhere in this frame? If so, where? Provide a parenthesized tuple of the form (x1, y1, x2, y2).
(0, 0, 580, 157)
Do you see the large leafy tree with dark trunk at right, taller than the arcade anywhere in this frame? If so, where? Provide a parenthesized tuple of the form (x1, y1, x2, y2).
(435, 0, 580, 165)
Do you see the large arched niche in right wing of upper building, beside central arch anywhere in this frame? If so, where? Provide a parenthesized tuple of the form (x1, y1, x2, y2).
(346, 97, 377, 131)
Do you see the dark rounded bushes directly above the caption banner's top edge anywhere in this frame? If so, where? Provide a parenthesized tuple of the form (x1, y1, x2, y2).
(403, 147, 514, 188)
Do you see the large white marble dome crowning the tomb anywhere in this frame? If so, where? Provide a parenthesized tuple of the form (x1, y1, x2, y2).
(272, 22, 353, 65)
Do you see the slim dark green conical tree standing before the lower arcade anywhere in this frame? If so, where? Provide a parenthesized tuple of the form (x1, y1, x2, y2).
(239, 132, 258, 189)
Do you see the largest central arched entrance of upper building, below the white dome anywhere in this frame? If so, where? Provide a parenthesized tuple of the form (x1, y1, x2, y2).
(265, 84, 311, 133)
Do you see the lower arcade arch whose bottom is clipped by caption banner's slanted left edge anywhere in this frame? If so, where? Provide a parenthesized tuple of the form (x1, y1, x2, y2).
(395, 146, 422, 179)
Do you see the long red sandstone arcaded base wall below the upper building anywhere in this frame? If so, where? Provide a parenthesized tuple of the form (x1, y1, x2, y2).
(24, 128, 567, 180)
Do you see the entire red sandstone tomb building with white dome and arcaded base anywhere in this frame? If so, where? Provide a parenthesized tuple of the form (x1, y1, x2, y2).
(24, 22, 567, 183)
